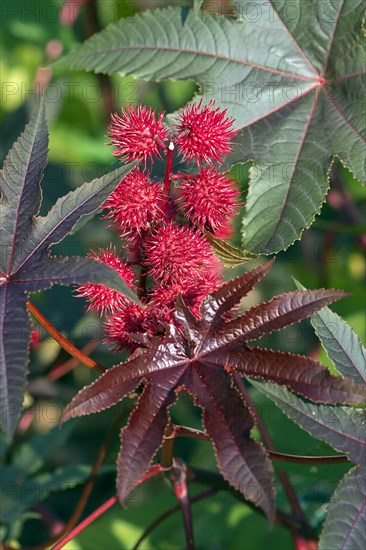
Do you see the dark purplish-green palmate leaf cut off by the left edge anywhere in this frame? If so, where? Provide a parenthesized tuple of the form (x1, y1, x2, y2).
(0, 101, 137, 437)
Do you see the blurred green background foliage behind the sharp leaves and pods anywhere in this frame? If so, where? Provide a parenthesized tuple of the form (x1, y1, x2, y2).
(0, 0, 366, 550)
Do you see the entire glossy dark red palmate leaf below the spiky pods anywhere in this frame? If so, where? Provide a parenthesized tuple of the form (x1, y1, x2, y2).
(62, 263, 366, 518)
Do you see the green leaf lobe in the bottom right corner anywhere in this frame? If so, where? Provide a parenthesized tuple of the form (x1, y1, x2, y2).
(319, 467, 366, 550)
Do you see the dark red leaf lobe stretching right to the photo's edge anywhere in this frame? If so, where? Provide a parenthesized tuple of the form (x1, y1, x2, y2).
(214, 346, 366, 404)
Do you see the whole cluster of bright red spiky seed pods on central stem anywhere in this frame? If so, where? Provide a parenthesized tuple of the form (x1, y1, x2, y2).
(78, 102, 239, 349)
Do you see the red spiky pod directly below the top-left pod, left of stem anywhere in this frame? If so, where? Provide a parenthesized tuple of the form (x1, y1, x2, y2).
(103, 168, 162, 236)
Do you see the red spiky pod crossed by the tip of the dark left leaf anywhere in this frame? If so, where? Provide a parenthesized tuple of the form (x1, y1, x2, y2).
(77, 246, 135, 316)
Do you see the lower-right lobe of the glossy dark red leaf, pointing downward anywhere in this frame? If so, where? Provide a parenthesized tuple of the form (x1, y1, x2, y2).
(187, 364, 274, 520)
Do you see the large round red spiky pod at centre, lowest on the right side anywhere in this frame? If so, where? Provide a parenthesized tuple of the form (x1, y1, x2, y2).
(144, 222, 215, 285)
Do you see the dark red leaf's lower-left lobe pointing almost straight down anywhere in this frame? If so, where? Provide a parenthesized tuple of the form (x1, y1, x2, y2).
(117, 368, 184, 504)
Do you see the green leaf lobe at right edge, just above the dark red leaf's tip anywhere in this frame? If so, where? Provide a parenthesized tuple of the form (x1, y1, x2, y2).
(294, 279, 366, 384)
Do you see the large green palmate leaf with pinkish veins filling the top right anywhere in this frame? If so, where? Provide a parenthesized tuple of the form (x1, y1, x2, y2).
(60, 0, 366, 254)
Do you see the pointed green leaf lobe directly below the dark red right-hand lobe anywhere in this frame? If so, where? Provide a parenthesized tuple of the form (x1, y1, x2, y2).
(251, 381, 366, 464)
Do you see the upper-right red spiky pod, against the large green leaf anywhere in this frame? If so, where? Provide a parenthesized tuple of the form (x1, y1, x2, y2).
(174, 100, 238, 164)
